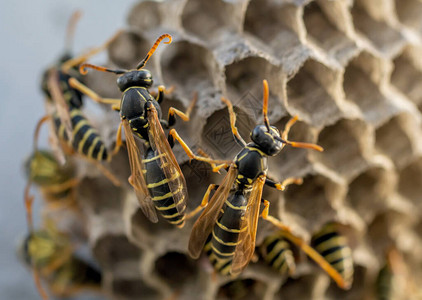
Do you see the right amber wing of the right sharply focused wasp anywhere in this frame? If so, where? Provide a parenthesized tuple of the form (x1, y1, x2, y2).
(230, 175, 266, 275)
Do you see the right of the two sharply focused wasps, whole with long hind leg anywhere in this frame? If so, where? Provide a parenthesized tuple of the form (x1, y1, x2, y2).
(170, 80, 346, 287)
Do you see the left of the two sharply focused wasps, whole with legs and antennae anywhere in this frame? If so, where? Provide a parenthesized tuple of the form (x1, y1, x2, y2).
(70, 34, 204, 227)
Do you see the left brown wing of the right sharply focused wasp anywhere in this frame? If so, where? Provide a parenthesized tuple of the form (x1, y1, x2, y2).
(188, 164, 237, 258)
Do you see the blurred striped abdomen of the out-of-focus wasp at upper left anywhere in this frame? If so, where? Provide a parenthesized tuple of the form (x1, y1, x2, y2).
(54, 108, 108, 160)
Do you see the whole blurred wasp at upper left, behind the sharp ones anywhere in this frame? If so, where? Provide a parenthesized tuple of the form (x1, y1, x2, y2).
(36, 11, 119, 180)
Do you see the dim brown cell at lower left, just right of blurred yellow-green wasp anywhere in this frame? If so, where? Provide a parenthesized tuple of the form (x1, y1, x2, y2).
(92, 234, 141, 271)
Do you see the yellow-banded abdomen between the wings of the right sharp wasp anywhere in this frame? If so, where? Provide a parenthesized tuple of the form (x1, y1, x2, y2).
(211, 192, 247, 261)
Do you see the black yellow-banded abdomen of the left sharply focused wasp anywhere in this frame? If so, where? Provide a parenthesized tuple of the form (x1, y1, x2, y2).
(142, 148, 186, 225)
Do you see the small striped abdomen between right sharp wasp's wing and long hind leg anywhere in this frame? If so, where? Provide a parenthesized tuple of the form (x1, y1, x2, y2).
(260, 232, 296, 276)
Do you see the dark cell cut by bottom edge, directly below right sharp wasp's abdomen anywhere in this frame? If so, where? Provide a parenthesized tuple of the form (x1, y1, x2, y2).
(216, 279, 266, 300)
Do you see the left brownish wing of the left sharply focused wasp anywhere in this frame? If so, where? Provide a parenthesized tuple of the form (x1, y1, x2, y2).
(122, 120, 158, 223)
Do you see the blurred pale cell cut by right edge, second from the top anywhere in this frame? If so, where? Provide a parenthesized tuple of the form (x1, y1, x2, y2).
(391, 53, 422, 110)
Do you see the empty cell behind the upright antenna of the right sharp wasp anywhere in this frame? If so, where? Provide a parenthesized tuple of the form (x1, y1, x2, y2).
(225, 57, 285, 123)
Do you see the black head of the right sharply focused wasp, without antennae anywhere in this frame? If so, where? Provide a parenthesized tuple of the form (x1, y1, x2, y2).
(251, 125, 284, 156)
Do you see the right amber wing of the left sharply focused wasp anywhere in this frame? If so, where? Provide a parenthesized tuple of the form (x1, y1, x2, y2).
(148, 105, 188, 214)
